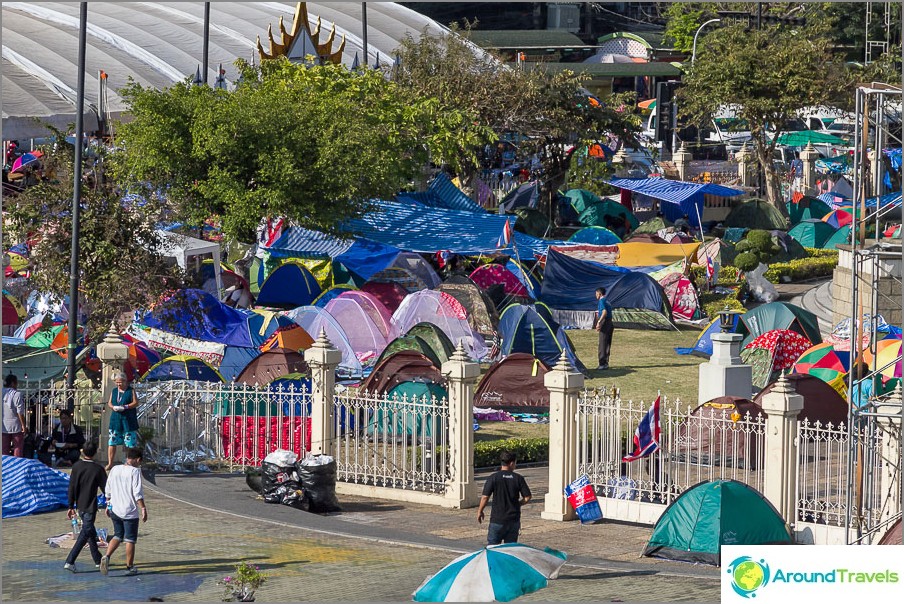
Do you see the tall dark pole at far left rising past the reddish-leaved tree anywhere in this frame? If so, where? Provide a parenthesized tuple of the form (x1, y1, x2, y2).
(66, 2, 88, 402)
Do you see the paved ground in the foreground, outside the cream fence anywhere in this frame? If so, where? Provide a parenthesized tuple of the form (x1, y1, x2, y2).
(2, 467, 719, 602)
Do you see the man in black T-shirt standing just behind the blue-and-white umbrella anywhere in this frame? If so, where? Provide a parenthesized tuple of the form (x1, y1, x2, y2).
(477, 451, 531, 545)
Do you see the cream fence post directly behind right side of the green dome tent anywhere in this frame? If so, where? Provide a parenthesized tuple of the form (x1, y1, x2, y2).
(761, 376, 804, 525)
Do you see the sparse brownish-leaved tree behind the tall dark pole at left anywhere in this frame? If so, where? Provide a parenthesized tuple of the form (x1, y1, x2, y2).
(3, 132, 180, 341)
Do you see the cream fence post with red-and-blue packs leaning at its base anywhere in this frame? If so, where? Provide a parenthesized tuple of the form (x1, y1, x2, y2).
(540, 350, 584, 521)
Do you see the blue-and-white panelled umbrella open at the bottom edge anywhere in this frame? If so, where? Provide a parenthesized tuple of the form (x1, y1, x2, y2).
(413, 543, 567, 602)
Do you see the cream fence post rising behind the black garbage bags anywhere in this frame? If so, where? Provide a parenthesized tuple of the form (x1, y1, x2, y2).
(304, 328, 342, 455)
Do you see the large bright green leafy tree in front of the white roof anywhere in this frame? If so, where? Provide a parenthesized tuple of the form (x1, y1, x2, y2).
(116, 58, 494, 241)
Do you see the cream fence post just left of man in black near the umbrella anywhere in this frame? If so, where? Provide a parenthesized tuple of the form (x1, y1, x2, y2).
(442, 342, 480, 509)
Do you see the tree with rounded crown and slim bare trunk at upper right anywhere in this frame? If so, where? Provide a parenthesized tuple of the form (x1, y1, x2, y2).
(677, 20, 852, 213)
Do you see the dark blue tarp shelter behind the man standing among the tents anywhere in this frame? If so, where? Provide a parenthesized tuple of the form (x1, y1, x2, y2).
(540, 250, 671, 317)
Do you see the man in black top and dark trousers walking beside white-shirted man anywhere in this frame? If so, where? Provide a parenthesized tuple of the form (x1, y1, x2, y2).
(63, 441, 107, 573)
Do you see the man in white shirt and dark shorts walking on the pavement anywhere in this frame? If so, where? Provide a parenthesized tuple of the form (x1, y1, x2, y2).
(100, 448, 148, 575)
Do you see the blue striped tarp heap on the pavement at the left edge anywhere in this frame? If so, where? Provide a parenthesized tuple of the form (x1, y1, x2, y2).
(0, 455, 69, 518)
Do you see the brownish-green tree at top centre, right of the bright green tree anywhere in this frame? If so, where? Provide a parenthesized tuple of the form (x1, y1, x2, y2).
(394, 24, 640, 219)
